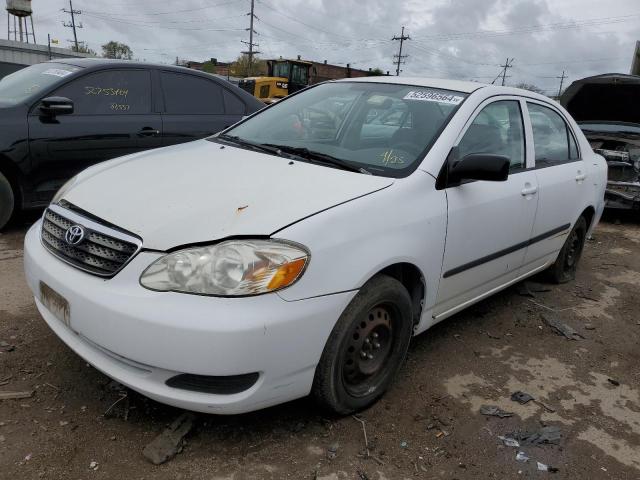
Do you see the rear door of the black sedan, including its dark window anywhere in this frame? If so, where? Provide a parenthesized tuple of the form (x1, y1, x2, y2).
(160, 71, 246, 145)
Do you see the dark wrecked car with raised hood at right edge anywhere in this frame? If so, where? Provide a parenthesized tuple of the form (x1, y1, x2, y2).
(560, 73, 640, 210)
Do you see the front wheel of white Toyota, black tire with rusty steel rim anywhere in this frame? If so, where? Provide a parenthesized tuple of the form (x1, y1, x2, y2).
(312, 275, 413, 415)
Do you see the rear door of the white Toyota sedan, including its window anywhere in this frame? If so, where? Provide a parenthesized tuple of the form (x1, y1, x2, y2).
(524, 100, 590, 270)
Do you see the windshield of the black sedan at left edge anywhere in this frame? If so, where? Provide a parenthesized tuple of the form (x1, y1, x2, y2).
(0, 62, 80, 105)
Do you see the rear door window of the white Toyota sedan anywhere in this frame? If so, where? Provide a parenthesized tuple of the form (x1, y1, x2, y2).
(527, 103, 578, 166)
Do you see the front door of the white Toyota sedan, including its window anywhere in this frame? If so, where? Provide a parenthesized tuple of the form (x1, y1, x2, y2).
(434, 98, 538, 317)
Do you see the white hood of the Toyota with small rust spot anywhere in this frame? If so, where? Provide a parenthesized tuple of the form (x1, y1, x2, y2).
(63, 140, 393, 250)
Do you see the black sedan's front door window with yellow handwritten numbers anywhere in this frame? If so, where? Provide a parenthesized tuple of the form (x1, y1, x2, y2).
(52, 70, 151, 115)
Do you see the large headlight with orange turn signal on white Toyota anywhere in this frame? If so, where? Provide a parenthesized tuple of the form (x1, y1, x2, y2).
(140, 240, 309, 297)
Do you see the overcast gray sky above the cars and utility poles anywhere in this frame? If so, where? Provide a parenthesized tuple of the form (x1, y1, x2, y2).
(25, 0, 640, 93)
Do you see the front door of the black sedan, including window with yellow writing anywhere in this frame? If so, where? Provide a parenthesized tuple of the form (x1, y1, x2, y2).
(28, 69, 162, 200)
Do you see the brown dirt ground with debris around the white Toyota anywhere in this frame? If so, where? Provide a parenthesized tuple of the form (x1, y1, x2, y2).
(0, 214, 640, 480)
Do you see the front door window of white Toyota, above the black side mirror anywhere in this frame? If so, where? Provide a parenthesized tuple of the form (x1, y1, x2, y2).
(458, 100, 525, 171)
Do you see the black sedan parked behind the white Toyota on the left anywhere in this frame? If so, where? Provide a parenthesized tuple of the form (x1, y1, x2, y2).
(0, 59, 264, 228)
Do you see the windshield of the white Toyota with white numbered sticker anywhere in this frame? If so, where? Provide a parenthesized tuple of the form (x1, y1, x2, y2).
(218, 82, 466, 177)
